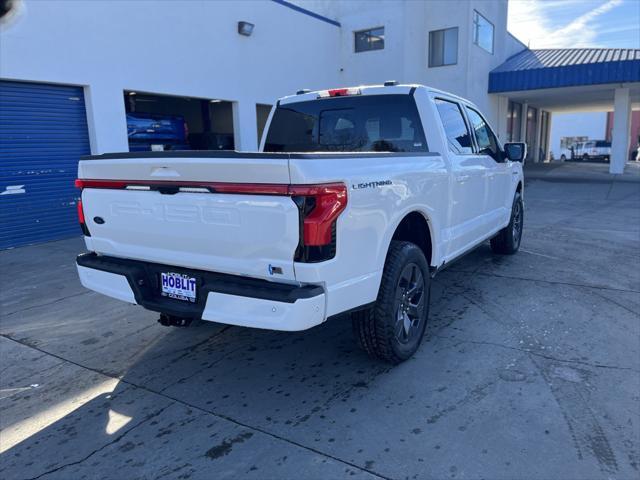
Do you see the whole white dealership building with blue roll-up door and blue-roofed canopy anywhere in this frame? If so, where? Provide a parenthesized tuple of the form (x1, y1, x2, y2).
(0, 0, 640, 249)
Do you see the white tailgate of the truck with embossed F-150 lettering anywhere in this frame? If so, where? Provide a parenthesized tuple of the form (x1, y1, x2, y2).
(79, 154, 299, 281)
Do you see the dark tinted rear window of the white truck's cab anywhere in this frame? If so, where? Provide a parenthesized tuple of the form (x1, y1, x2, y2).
(264, 94, 427, 152)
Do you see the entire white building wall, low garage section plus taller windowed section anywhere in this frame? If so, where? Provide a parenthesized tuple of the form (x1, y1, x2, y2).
(0, 0, 522, 153)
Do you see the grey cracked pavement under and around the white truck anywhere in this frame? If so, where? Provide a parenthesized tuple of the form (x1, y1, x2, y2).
(0, 176, 640, 480)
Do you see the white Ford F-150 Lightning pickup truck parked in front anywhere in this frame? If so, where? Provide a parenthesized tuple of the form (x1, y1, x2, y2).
(76, 82, 526, 363)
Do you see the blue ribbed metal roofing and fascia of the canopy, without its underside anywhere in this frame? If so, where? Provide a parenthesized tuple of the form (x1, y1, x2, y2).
(489, 48, 640, 93)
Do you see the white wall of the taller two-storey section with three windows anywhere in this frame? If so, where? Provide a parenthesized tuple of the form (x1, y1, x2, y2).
(295, 0, 525, 131)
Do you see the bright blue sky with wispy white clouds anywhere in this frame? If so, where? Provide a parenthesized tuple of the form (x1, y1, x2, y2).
(508, 0, 640, 48)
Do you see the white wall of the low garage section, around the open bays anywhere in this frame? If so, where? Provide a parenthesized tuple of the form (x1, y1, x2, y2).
(0, 0, 340, 153)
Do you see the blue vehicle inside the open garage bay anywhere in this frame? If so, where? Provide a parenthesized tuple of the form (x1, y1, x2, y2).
(127, 112, 190, 152)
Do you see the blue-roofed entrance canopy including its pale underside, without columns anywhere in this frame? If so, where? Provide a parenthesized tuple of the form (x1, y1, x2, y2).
(489, 48, 640, 111)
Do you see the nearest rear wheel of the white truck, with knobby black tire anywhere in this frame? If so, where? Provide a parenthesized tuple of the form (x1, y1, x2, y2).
(351, 241, 430, 364)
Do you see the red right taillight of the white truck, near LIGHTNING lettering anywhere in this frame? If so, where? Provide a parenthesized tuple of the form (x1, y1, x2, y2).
(289, 183, 347, 247)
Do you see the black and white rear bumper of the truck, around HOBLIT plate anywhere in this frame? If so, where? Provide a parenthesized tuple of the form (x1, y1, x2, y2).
(76, 253, 325, 331)
